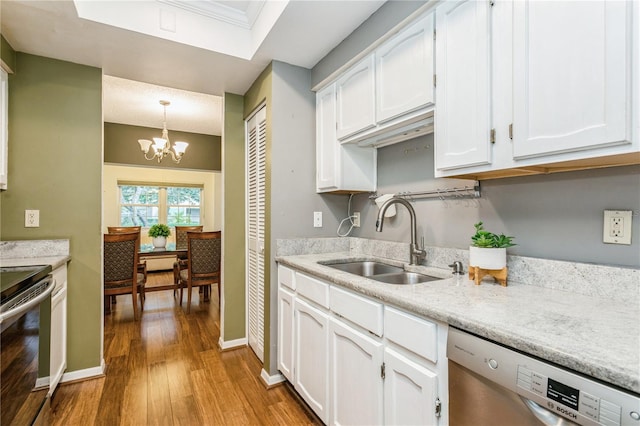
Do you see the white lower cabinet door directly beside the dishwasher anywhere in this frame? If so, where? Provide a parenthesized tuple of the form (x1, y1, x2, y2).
(384, 348, 438, 425)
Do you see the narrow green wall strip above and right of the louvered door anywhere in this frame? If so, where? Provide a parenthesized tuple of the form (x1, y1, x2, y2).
(242, 64, 273, 372)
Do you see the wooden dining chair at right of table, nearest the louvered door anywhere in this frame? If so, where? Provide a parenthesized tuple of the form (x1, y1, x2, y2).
(180, 231, 222, 313)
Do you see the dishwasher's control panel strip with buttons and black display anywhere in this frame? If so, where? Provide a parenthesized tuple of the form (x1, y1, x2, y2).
(447, 327, 640, 426)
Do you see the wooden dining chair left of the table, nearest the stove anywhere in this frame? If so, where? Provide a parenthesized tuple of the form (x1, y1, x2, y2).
(103, 232, 145, 320)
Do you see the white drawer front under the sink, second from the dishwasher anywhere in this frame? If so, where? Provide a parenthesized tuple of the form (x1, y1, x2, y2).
(331, 287, 383, 336)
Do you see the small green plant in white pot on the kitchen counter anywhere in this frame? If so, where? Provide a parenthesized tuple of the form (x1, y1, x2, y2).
(469, 222, 515, 270)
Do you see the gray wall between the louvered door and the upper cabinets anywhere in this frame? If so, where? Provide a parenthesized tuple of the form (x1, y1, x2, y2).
(265, 61, 345, 373)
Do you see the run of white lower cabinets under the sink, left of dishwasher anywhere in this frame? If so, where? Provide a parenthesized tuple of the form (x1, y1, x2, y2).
(278, 265, 448, 426)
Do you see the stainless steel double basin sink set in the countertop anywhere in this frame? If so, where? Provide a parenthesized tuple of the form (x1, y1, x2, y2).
(325, 260, 442, 284)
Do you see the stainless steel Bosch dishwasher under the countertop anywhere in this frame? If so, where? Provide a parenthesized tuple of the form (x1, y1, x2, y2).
(447, 327, 640, 426)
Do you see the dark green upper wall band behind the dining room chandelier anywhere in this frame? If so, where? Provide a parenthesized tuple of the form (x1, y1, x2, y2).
(104, 123, 221, 171)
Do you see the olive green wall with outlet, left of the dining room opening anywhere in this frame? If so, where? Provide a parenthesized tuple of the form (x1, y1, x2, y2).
(0, 53, 102, 371)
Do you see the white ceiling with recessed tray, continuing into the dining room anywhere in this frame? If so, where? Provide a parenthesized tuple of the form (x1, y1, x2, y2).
(0, 0, 385, 135)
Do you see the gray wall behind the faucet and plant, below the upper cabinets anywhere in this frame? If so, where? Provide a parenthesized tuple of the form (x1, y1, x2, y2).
(352, 135, 640, 267)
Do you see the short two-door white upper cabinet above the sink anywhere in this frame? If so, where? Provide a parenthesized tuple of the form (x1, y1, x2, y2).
(322, 7, 434, 147)
